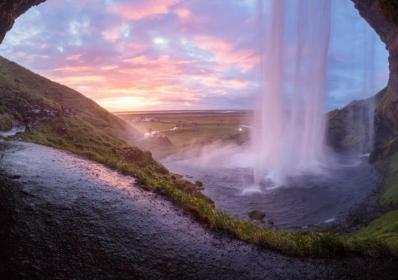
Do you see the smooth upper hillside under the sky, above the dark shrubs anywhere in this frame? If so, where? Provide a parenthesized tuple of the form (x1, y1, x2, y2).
(0, 57, 137, 141)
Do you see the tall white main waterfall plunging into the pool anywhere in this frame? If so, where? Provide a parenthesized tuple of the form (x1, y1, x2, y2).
(252, 0, 331, 185)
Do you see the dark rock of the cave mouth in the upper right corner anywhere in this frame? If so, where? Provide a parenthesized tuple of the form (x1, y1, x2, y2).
(352, 0, 398, 129)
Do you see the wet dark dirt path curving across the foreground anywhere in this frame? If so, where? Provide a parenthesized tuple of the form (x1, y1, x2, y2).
(0, 142, 397, 280)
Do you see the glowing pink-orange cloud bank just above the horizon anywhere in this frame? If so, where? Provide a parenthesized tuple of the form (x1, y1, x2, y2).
(44, 49, 249, 111)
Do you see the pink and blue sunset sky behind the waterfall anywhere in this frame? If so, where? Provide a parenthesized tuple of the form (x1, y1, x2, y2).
(0, 0, 388, 112)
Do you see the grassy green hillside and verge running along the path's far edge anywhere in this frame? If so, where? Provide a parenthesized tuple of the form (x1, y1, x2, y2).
(0, 55, 393, 256)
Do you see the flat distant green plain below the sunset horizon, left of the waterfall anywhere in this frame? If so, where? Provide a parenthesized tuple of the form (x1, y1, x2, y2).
(117, 111, 252, 157)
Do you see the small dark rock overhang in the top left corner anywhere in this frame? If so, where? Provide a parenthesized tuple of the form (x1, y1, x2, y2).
(0, 0, 45, 43)
